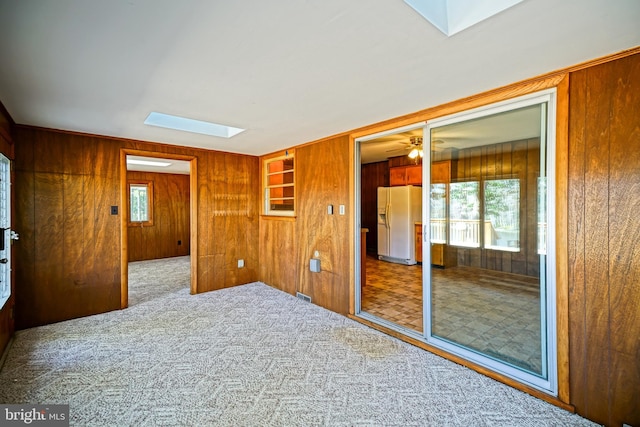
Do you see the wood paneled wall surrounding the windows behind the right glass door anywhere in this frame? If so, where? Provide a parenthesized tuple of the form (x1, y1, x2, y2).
(450, 138, 540, 277)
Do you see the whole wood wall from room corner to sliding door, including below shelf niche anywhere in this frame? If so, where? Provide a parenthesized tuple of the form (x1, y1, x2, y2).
(260, 136, 353, 314)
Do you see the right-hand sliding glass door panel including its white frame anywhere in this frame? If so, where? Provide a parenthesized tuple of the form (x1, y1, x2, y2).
(423, 91, 557, 394)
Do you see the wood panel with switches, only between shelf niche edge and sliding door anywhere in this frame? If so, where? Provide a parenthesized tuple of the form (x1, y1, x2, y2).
(296, 137, 354, 314)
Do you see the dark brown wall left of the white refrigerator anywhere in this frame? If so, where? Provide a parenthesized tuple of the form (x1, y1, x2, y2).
(360, 160, 390, 255)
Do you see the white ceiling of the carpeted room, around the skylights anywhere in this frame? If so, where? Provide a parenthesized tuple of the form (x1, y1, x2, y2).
(0, 0, 640, 159)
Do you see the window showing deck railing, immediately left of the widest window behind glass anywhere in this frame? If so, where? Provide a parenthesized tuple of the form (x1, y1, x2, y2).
(449, 181, 480, 248)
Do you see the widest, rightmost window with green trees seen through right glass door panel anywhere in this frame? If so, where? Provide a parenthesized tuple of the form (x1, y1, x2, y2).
(484, 179, 520, 251)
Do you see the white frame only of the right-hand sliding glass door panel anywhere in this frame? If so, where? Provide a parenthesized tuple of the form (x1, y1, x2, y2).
(422, 88, 558, 396)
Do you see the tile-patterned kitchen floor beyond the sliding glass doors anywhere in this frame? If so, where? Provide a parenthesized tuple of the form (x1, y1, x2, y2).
(362, 256, 542, 374)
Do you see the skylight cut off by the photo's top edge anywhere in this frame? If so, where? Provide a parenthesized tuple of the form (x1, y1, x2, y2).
(404, 0, 522, 36)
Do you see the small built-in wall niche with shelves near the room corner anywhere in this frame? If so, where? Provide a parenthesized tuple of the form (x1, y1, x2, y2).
(263, 154, 295, 216)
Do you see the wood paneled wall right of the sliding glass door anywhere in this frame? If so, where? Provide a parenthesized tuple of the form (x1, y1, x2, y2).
(568, 55, 640, 426)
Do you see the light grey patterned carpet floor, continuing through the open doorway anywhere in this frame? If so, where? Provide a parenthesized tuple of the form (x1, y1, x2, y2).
(0, 258, 593, 426)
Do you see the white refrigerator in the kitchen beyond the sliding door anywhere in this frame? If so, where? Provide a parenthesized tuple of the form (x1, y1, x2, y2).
(378, 185, 422, 265)
